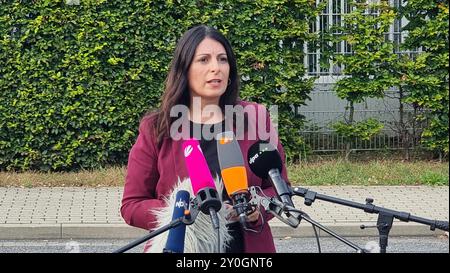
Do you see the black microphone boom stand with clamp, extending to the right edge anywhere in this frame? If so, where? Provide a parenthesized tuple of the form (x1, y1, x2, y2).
(291, 187, 449, 253)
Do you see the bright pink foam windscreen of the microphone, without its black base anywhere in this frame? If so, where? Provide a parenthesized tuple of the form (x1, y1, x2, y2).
(183, 138, 216, 195)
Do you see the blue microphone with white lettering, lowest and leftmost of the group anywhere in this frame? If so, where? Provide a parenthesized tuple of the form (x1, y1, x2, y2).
(163, 190, 190, 253)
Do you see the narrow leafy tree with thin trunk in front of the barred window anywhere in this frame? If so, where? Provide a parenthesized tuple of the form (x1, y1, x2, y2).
(333, 1, 396, 159)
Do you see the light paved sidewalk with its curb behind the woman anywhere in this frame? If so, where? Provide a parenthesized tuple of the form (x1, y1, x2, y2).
(0, 186, 449, 239)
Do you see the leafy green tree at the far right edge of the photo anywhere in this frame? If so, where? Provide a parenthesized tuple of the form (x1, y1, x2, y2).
(400, 0, 449, 158)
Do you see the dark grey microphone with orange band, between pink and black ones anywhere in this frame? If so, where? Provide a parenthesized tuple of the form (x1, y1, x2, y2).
(216, 131, 249, 227)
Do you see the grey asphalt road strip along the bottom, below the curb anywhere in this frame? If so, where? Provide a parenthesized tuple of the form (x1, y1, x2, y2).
(0, 236, 449, 253)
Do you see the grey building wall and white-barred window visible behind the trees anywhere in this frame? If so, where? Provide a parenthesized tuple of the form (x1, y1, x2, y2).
(299, 0, 423, 152)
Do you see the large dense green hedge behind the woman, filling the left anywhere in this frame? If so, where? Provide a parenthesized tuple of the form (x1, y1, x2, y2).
(0, 0, 317, 171)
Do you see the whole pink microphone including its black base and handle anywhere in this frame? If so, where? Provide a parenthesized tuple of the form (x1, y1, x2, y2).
(183, 138, 222, 229)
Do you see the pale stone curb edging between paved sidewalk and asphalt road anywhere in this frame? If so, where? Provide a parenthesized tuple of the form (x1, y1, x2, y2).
(0, 221, 445, 240)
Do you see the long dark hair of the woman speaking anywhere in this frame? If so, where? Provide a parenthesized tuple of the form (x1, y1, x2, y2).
(149, 25, 239, 146)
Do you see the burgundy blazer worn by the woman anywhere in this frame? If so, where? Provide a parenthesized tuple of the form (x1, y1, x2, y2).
(121, 101, 290, 253)
